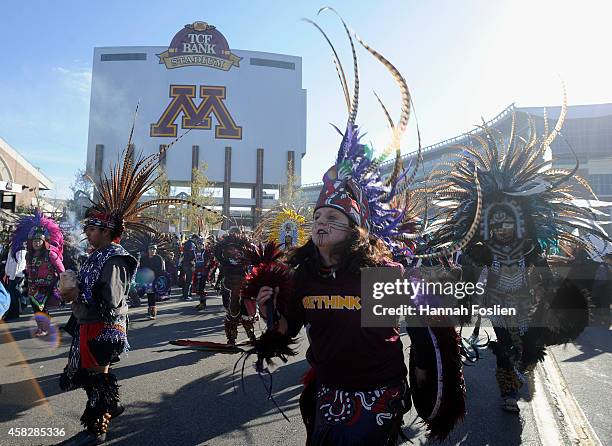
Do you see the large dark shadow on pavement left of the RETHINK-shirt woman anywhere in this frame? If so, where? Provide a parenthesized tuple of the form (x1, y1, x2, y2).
(109, 358, 307, 446)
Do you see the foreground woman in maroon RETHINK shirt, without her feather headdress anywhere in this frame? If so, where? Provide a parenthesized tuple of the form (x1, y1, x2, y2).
(257, 205, 410, 445)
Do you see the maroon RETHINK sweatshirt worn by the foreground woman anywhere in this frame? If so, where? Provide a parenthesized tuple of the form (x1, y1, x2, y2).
(285, 265, 407, 390)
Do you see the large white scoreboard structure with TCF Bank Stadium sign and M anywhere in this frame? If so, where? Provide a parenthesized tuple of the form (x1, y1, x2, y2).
(87, 22, 306, 230)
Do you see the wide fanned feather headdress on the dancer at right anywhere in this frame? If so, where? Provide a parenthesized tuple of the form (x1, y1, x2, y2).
(431, 91, 609, 254)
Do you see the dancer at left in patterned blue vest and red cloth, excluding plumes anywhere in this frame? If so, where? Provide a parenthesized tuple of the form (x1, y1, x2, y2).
(59, 212, 138, 441)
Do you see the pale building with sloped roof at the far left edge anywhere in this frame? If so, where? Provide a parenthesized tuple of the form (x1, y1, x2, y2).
(0, 138, 54, 214)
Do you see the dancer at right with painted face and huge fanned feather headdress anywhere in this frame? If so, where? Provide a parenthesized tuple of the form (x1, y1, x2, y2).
(432, 98, 607, 412)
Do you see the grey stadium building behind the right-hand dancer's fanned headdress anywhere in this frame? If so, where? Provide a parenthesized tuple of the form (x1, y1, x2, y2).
(302, 104, 612, 233)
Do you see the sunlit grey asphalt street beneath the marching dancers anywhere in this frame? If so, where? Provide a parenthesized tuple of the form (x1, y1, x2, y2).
(0, 290, 612, 446)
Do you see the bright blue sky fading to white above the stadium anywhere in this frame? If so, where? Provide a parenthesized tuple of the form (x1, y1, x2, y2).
(0, 0, 612, 197)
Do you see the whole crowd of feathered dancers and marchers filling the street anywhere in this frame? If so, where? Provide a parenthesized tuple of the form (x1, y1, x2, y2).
(0, 14, 612, 445)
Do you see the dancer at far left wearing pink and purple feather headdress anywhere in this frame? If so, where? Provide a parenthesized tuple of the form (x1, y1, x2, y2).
(11, 210, 64, 336)
